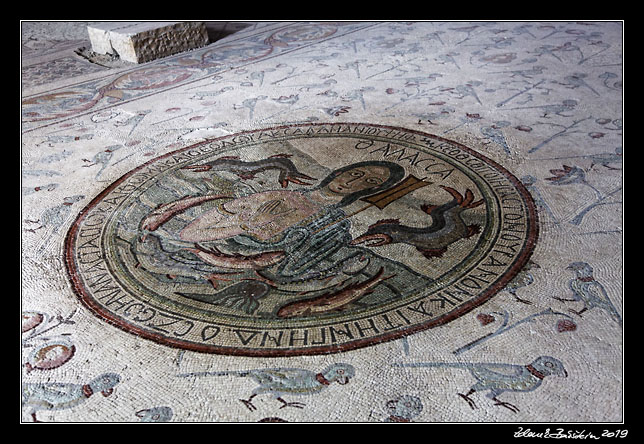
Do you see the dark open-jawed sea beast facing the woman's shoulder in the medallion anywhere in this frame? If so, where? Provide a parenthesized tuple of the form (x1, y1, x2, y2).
(351, 185, 483, 259)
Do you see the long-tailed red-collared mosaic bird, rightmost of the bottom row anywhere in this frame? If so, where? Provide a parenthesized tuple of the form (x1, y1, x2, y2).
(394, 356, 568, 413)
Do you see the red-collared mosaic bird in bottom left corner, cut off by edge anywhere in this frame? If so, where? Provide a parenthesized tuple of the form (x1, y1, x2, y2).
(22, 373, 121, 422)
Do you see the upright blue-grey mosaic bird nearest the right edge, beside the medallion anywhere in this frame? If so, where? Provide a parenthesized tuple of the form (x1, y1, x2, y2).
(555, 262, 622, 325)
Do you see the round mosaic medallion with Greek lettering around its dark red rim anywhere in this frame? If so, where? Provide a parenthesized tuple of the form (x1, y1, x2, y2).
(65, 123, 537, 356)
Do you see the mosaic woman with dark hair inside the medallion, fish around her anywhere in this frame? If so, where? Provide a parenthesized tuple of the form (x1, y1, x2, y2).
(133, 161, 431, 316)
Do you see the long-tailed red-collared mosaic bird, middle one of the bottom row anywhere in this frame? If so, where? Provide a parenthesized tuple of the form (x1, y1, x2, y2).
(178, 363, 355, 411)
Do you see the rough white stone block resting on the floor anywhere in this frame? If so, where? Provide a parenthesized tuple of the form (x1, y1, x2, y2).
(87, 22, 209, 63)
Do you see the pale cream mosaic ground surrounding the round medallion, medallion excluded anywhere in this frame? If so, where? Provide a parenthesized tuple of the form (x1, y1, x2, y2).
(20, 21, 625, 423)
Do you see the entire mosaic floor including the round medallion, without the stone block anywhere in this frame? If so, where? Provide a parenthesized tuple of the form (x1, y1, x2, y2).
(21, 21, 624, 426)
